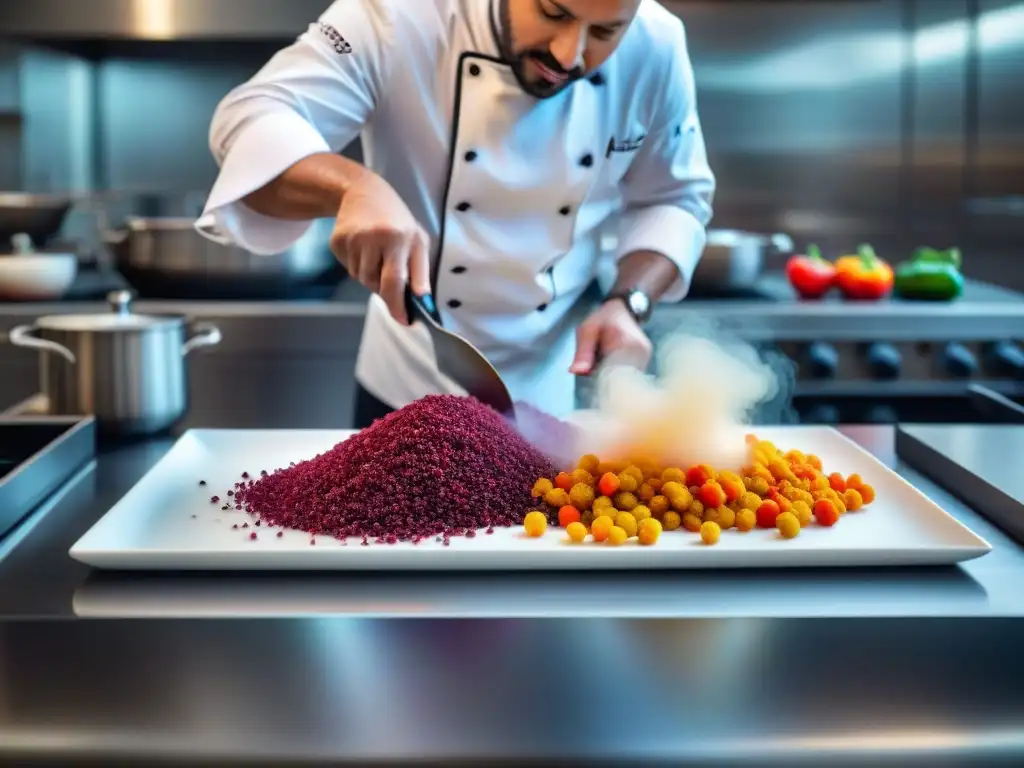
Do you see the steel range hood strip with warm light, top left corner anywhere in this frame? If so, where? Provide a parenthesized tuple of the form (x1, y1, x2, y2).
(0, 0, 331, 40)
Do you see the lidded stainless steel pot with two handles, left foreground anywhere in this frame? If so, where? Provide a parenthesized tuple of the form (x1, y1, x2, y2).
(9, 291, 221, 435)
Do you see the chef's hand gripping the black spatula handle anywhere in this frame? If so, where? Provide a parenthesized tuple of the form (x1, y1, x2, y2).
(331, 173, 430, 325)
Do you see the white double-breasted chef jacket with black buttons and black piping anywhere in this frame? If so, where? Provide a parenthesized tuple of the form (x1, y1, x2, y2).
(197, 0, 715, 416)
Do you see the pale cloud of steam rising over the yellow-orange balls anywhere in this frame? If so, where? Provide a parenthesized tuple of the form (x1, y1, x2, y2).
(572, 321, 797, 468)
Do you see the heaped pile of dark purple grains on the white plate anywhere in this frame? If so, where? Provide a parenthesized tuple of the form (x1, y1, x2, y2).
(236, 395, 555, 544)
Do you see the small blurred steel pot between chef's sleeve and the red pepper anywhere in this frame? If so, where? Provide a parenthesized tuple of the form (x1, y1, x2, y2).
(691, 229, 794, 291)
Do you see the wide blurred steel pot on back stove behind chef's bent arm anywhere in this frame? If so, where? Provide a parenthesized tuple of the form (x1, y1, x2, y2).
(104, 217, 344, 298)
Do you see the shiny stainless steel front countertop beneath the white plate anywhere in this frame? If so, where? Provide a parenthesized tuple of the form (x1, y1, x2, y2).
(0, 427, 1024, 768)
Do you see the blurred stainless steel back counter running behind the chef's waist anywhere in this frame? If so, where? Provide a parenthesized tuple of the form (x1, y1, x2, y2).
(0, 273, 1024, 354)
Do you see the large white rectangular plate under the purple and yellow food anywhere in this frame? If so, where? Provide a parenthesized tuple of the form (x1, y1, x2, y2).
(71, 426, 991, 570)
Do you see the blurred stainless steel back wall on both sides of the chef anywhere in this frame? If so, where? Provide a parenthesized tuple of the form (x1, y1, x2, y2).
(0, 0, 1024, 287)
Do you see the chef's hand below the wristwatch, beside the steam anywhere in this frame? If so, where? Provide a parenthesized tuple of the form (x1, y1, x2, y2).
(569, 299, 653, 376)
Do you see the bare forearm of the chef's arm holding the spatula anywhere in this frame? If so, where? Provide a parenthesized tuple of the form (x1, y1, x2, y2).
(245, 153, 373, 221)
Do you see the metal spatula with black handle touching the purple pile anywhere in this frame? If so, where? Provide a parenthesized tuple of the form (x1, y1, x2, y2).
(406, 286, 515, 421)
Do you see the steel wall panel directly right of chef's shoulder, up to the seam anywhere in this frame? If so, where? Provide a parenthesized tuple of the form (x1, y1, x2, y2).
(673, 0, 905, 244)
